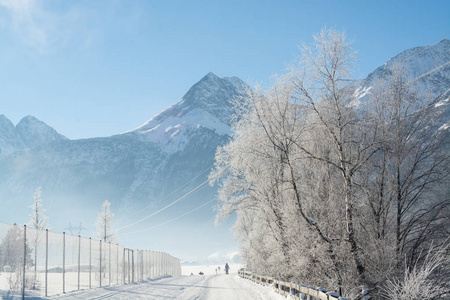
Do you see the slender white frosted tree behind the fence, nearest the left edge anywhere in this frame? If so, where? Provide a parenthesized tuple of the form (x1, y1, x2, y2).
(29, 187, 48, 288)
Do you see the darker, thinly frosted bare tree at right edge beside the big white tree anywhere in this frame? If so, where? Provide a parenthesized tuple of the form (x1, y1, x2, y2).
(360, 64, 450, 298)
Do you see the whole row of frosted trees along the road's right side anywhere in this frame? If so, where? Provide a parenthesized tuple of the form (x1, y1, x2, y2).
(210, 29, 450, 299)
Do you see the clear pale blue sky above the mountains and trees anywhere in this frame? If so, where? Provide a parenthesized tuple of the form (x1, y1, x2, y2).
(0, 0, 450, 139)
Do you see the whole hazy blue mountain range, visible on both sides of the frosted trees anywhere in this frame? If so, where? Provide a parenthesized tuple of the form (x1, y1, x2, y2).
(0, 40, 450, 260)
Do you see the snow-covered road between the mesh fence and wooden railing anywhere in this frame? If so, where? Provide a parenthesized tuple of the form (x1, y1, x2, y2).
(46, 274, 286, 300)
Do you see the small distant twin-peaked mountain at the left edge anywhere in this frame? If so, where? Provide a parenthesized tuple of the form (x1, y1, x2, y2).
(0, 115, 67, 158)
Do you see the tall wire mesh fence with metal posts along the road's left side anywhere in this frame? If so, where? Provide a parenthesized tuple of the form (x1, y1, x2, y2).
(0, 222, 181, 297)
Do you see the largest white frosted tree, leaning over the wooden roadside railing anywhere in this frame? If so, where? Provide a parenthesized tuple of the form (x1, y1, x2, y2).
(211, 30, 370, 296)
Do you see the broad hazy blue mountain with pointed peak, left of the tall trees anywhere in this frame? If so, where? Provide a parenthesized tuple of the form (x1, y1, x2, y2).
(0, 73, 246, 237)
